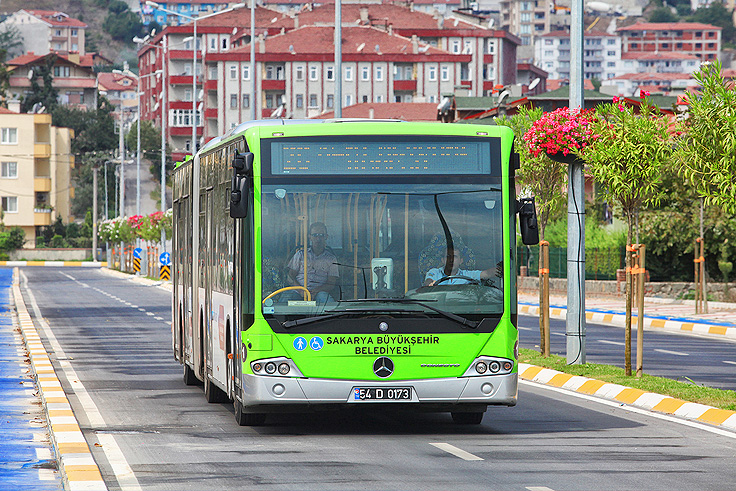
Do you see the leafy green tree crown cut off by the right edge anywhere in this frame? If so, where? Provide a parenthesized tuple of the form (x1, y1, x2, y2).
(676, 61, 736, 215)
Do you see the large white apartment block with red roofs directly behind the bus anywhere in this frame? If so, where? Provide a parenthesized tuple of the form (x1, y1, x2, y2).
(138, 4, 519, 158)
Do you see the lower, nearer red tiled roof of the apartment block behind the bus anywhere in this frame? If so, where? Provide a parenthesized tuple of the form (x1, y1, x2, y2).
(233, 26, 450, 56)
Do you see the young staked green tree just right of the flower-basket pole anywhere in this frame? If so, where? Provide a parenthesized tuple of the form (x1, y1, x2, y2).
(581, 99, 672, 375)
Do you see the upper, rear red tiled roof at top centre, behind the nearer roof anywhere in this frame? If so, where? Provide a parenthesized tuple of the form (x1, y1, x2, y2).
(274, 2, 485, 29)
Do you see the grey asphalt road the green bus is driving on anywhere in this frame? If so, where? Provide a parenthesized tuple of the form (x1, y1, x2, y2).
(17, 268, 736, 491)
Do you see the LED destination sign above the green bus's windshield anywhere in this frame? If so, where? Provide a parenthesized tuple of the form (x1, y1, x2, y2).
(270, 137, 499, 175)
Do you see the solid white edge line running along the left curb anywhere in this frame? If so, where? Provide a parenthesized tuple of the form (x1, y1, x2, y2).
(20, 270, 141, 491)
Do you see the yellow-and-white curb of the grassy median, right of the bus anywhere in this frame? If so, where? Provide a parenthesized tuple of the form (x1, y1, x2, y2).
(519, 363, 736, 431)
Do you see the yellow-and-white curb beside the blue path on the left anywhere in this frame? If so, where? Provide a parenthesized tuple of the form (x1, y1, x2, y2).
(13, 270, 107, 491)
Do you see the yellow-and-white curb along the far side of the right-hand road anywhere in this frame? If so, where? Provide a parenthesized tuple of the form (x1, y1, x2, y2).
(519, 304, 736, 340)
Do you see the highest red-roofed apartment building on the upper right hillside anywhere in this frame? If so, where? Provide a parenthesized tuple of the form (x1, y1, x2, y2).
(616, 22, 722, 61)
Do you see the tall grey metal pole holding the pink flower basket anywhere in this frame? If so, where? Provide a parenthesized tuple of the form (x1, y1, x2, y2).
(565, 0, 585, 365)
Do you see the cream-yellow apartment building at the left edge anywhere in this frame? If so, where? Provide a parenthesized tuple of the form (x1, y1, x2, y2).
(0, 108, 74, 248)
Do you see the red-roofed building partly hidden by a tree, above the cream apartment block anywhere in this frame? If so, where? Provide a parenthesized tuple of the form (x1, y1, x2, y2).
(7, 52, 109, 109)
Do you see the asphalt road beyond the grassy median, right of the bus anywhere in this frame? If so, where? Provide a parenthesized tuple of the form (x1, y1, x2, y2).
(519, 316, 736, 390)
